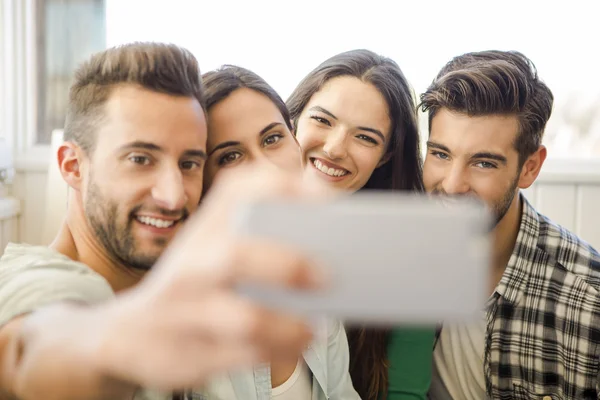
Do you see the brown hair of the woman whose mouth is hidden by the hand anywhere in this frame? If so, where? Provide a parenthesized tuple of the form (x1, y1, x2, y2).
(202, 65, 292, 130)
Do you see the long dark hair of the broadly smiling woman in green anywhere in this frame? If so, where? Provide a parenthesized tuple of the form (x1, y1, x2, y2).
(287, 50, 423, 400)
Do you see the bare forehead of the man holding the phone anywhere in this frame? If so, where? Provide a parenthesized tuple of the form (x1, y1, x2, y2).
(96, 85, 206, 149)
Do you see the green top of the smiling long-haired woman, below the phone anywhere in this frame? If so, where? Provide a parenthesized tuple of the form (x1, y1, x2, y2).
(387, 327, 435, 400)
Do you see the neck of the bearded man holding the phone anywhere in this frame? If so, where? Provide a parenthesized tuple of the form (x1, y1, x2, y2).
(50, 196, 145, 292)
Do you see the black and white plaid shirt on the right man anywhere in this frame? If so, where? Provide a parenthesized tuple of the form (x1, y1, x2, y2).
(484, 196, 600, 400)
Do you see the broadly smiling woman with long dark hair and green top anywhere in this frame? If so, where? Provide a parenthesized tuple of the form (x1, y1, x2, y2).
(287, 50, 435, 400)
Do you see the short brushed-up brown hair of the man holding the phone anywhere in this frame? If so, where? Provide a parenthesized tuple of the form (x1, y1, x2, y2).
(64, 43, 204, 152)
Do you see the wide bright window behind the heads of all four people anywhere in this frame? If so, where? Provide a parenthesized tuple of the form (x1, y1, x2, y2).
(19, 0, 600, 159)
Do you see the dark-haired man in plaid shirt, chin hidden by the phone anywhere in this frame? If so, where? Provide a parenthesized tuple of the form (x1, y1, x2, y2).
(421, 51, 600, 400)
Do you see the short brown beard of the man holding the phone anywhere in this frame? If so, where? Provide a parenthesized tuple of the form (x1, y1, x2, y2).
(85, 179, 189, 271)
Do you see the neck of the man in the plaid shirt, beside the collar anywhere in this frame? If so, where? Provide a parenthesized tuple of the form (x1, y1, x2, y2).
(490, 192, 523, 292)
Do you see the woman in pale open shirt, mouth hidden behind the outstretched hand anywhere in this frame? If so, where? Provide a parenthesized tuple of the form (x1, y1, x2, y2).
(197, 66, 360, 400)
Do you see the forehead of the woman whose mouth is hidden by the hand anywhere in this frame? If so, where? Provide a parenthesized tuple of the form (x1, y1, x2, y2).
(208, 88, 286, 147)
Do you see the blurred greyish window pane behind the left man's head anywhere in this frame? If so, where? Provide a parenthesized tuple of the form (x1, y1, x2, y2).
(35, 0, 106, 144)
